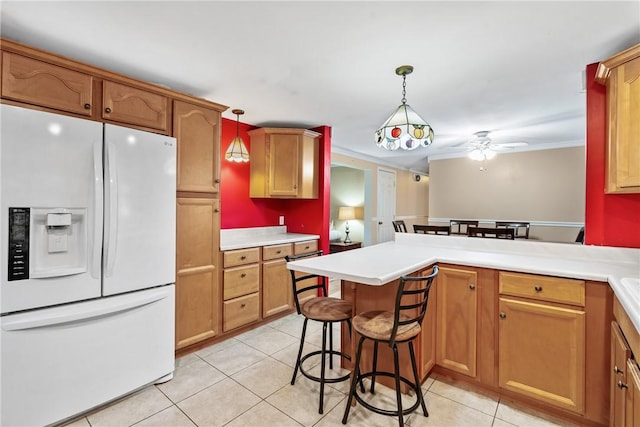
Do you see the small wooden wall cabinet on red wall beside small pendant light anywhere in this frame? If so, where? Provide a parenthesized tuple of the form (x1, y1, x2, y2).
(249, 128, 320, 199)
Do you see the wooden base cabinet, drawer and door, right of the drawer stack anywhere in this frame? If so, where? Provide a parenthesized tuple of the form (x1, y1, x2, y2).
(262, 243, 293, 318)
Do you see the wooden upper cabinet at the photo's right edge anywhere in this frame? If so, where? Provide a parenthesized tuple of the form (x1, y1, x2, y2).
(596, 44, 640, 193)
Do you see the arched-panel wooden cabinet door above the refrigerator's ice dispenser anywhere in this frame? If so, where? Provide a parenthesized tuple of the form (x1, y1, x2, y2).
(2, 52, 93, 116)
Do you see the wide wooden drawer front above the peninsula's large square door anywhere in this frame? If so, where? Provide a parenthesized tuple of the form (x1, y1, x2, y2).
(500, 271, 585, 306)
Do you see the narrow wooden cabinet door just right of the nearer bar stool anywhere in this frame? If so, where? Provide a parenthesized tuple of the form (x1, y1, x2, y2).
(436, 268, 478, 377)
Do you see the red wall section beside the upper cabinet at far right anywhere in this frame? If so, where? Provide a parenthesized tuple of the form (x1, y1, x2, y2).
(585, 63, 640, 248)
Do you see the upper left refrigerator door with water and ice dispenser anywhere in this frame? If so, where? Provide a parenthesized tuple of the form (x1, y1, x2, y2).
(0, 104, 103, 313)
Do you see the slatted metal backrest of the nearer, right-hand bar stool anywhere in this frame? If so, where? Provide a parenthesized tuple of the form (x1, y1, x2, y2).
(389, 265, 438, 347)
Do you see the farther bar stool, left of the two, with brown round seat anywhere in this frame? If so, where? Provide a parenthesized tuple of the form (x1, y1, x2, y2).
(285, 250, 353, 414)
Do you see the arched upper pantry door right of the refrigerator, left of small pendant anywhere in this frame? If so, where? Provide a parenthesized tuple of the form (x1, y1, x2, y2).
(173, 101, 220, 193)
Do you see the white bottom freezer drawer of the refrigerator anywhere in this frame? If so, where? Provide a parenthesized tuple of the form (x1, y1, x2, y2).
(0, 285, 175, 427)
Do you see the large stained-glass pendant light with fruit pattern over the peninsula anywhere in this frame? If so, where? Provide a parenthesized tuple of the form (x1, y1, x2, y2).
(375, 65, 434, 151)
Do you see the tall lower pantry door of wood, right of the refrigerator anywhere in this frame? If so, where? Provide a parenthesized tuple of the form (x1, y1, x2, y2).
(176, 198, 220, 349)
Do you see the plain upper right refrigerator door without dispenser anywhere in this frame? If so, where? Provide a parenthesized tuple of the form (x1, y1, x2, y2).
(102, 125, 176, 295)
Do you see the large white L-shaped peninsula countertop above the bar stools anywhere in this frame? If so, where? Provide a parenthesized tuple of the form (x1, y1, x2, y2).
(287, 233, 640, 338)
